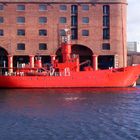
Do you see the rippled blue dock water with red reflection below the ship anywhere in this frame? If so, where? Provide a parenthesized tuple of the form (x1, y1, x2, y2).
(0, 87, 140, 140)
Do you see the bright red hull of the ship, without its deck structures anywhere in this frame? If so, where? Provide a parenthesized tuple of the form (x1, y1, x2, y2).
(0, 66, 140, 88)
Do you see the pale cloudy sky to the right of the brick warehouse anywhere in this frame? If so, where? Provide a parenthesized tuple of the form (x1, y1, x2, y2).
(127, 0, 140, 41)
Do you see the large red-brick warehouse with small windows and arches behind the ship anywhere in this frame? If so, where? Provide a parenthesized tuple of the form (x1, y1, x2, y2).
(0, 0, 127, 68)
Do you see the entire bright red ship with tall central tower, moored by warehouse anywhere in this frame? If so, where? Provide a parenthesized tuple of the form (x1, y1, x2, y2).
(0, 29, 140, 88)
